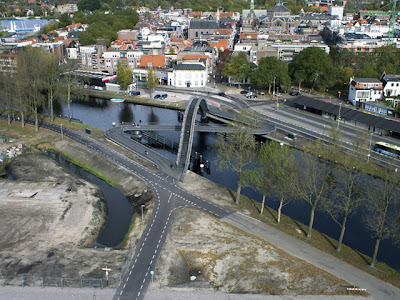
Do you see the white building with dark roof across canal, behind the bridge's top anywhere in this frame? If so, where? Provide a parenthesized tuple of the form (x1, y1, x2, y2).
(168, 62, 207, 88)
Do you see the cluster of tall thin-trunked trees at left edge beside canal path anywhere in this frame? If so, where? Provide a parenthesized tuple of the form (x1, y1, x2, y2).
(0, 47, 85, 130)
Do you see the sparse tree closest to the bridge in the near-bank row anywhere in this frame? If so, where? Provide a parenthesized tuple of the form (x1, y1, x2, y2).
(217, 110, 256, 204)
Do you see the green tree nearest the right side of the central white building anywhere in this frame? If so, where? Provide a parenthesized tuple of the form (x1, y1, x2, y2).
(222, 52, 254, 88)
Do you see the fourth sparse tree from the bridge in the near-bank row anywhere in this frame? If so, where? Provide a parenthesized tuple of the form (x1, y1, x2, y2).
(294, 140, 332, 238)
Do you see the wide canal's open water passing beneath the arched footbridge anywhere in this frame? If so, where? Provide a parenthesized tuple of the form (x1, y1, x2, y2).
(56, 98, 400, 269)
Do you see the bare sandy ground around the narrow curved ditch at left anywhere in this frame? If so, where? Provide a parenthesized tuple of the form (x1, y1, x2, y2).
(0, 123, 153, 286)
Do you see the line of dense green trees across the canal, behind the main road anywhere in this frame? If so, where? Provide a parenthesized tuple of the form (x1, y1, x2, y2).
(221, 46, 400, 95)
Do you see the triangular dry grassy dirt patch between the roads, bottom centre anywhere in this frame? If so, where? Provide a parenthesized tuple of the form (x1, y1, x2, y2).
(153, 209, 346, 295)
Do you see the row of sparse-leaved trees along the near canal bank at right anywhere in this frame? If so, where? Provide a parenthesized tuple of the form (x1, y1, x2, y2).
(217, 112, 400, 266)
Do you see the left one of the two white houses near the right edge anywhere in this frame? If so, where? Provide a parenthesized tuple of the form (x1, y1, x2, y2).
(348, 78, 383, 106)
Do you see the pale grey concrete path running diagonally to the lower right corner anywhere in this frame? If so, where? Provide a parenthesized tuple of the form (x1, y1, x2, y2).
(222, 213, 400, 300)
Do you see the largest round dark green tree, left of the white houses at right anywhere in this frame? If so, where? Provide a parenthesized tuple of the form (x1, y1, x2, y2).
(291, 47, 334, 87)
